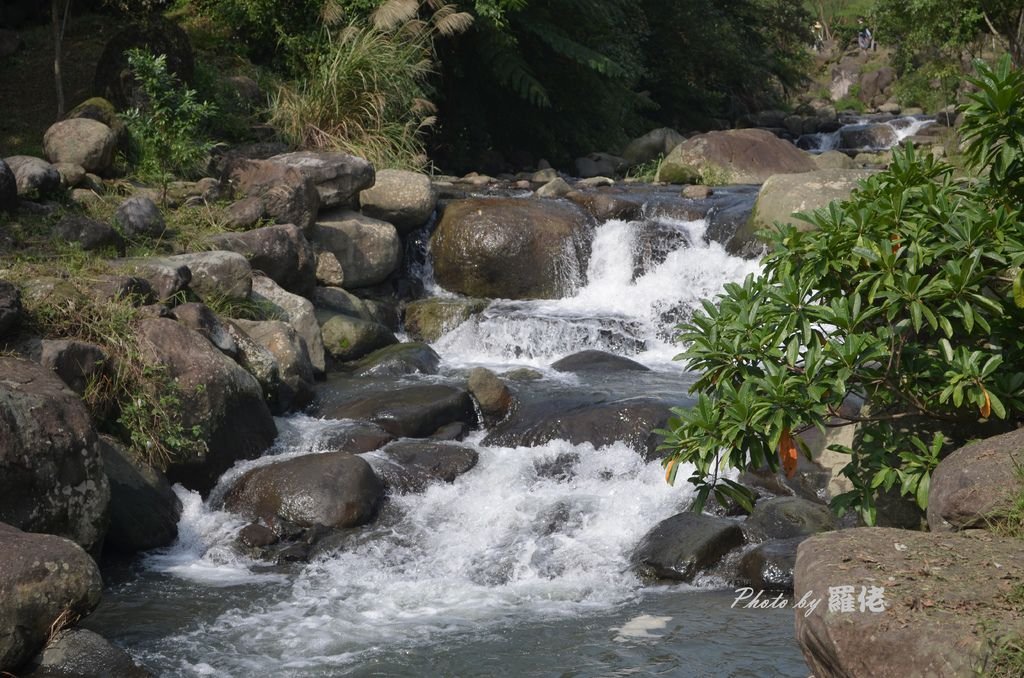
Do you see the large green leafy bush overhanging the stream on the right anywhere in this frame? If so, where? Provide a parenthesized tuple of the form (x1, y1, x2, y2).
(663, 59, 1024, 524)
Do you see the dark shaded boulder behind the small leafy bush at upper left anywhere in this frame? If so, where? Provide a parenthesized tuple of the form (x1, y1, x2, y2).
(92, 12, 196, 110)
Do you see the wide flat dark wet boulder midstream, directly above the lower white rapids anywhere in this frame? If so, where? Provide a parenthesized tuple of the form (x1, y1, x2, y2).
(483, 397, 675, 461)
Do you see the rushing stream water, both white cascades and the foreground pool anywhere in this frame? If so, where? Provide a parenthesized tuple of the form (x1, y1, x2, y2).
(86, 193, 807, 677)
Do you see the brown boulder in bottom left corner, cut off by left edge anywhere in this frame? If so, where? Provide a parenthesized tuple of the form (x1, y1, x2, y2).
(0, 522, 103, 672)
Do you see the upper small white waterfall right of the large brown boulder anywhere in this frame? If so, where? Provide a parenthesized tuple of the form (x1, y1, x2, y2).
(434, 216, 758, 369)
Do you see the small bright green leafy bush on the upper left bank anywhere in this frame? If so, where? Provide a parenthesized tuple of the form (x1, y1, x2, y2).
(125, 49, 215, 187)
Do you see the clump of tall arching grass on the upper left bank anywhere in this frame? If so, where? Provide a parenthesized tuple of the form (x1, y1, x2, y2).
(270, 22, 435, 169)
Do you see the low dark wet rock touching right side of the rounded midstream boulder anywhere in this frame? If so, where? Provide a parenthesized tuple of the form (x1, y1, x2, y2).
(366, 440, 479, 495)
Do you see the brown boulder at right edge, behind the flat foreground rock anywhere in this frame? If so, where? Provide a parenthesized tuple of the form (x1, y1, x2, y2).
(928, 429, 1024, 533)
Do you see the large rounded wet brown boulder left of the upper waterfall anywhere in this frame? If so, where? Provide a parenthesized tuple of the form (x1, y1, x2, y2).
(430, 198, 591, 299)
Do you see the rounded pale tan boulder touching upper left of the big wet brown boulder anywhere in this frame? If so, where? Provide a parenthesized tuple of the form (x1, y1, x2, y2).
(359, 170, 437, 236)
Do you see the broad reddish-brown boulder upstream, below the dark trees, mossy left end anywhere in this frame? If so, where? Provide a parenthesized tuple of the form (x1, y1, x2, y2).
(657, 129, 816, 184)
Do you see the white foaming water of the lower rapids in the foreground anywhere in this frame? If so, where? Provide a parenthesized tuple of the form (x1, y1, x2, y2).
(147, 441, 692, 675)
